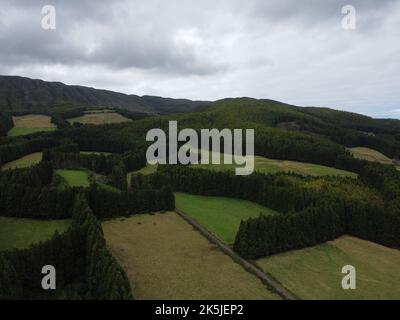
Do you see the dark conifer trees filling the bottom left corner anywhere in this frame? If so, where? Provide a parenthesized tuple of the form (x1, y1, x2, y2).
(0, 192, 132, 300)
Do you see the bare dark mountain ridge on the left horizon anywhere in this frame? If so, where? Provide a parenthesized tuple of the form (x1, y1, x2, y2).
(0, 76, 209, 114)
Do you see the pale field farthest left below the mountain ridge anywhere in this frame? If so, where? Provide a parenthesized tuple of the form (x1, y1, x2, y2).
(8, 114, 56, 136)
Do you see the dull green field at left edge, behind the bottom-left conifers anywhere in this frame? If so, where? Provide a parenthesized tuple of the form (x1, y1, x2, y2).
(0, 217, 71, 251)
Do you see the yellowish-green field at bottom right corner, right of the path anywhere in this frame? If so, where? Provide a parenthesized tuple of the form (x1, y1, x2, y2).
(257, 236, 400, 300)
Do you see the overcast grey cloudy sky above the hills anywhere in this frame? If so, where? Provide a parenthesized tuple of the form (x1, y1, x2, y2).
(0, 0, 400, 118)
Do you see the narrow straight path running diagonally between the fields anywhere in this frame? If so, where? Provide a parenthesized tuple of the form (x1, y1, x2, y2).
(175, 208, 299, 300)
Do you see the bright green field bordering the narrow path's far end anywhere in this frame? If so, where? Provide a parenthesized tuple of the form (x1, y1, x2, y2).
(175, 193, 278, 244)
